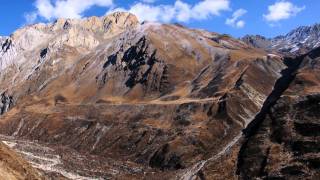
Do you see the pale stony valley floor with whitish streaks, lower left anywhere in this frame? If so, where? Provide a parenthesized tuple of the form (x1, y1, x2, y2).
(0, 135, 146, 180)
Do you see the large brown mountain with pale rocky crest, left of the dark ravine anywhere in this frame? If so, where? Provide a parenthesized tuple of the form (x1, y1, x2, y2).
(0, 13, 317, 179)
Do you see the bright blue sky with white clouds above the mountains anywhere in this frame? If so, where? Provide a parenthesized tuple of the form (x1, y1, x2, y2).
(0, 0, 320, 37)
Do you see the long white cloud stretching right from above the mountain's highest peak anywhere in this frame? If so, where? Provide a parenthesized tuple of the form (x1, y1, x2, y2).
(107, 0, 230, 22)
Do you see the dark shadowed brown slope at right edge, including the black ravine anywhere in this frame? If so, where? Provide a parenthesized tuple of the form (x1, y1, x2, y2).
(238, 48, 320, 179)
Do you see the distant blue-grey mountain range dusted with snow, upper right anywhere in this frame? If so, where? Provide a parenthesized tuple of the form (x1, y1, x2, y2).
(241, 24, 320, 54)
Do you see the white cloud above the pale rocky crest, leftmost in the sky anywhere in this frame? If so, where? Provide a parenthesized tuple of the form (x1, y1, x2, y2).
(25, 0, 113, 23)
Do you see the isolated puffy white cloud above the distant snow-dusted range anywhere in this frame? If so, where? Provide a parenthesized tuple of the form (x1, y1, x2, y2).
(263, 1, 305, 22)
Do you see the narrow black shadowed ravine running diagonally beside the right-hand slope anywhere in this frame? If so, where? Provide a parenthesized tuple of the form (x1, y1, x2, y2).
(237, 55, 306, 179)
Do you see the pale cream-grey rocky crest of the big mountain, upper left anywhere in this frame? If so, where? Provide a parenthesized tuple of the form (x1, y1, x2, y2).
(0, 12, 139, 72)
